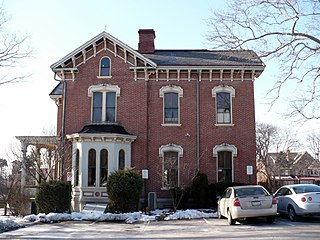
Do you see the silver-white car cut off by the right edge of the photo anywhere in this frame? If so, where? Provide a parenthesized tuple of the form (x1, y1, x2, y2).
(275, 184, 320, 221)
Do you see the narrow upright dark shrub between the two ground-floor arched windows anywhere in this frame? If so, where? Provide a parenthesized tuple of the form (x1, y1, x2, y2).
(191, 172, 209, 208)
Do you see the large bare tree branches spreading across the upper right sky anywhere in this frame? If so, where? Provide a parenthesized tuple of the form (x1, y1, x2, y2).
(207, 0, 320, 119)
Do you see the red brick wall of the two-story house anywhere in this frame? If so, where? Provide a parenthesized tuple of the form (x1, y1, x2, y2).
(58, 47, 255, 197)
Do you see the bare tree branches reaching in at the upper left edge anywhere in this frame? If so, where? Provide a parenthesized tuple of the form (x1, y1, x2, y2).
(0, 5, 31, 85)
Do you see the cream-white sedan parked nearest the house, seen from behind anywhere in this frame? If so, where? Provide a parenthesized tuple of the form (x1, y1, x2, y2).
(217, 185, 277, 225)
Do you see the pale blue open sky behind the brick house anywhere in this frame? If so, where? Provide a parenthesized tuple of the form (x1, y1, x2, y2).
(0, 0, 312, 158)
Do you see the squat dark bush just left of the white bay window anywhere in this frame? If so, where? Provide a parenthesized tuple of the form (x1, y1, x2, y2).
(35, 180, 71, 214)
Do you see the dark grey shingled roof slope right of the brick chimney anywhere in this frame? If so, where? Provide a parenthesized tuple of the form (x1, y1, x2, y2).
(143, 49, 264, 68)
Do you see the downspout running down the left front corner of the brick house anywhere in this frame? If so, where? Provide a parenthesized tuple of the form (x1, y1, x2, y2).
(54, 72, 67, 180)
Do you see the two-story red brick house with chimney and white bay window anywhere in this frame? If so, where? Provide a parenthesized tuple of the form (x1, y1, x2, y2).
(16, 29, 265, 210)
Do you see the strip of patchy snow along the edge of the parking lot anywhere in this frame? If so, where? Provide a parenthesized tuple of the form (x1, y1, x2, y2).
(0, 209, 217, 232)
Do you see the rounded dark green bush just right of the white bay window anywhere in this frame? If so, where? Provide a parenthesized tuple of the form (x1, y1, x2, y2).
(107, 168, 143, 212)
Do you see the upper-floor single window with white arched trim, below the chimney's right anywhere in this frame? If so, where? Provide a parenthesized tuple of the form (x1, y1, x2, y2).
(160, 84, 183, 125)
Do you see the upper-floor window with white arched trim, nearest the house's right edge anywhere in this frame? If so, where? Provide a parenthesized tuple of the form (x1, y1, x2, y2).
(212, 84, 235, 124)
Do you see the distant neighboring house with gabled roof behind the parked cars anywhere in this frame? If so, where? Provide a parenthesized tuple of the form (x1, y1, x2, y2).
(257, 151, 320, 190)
